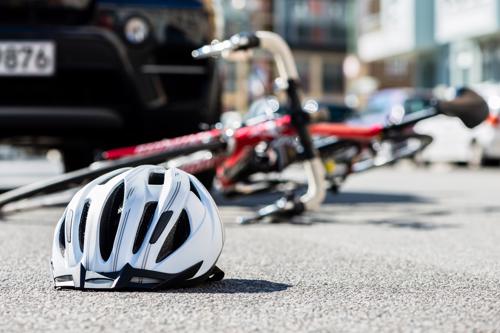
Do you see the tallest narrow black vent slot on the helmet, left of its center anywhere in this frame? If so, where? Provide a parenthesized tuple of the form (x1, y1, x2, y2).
(99, 183, 125, 261)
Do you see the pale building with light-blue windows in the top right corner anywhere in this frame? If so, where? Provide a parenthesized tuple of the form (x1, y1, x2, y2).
(435, 0, 500, 86)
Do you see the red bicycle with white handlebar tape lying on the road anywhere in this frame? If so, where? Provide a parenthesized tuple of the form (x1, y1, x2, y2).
(0, 31, 488, 223)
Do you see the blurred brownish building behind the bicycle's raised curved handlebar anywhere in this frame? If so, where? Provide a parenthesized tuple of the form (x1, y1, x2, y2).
(223, 0, 349, 110)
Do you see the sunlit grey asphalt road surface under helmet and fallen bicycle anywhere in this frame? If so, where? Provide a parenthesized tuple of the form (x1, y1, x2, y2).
(0, 167, 500, 333)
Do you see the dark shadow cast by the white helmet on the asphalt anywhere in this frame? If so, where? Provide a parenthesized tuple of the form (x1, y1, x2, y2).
(167, 279, 292, 294)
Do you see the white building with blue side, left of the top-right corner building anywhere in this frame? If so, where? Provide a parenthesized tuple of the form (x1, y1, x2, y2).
(356, 0, 438, 88)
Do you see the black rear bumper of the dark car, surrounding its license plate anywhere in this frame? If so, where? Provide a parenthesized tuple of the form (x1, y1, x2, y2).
(0, 24, 220, 140)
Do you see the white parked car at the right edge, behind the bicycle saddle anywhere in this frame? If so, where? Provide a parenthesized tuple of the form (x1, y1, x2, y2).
(415, 89, 500, 167)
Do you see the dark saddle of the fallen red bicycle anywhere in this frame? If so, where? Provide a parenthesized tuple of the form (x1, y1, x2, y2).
(437, 88, 489, 128)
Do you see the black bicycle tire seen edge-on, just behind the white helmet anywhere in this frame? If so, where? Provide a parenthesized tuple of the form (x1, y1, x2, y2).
(0, 141, 226, 209)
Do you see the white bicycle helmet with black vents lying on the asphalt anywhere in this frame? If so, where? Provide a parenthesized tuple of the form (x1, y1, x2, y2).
(52, 165, 224, 289)
